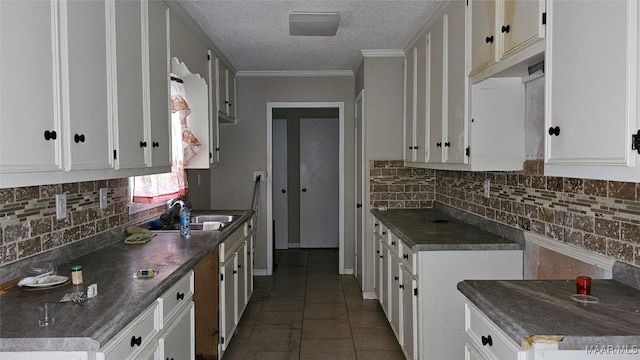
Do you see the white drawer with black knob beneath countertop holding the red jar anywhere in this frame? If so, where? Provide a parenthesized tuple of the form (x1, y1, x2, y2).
(465, 302, 521, 359)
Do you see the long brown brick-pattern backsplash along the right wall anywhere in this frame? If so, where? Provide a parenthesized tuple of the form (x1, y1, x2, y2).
(435, 160, 640, 265)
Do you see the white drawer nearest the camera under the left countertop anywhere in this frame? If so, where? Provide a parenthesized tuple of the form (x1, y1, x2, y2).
(102, 301, 162, 360)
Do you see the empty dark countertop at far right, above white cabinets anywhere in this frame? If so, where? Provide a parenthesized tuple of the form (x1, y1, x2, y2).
(371, 209, 522, 251)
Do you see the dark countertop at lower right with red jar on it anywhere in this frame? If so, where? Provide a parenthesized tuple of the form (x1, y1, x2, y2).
(458, 279, 640, 350)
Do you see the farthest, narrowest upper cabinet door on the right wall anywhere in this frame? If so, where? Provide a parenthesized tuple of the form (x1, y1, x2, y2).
(404, 48, 418, 162)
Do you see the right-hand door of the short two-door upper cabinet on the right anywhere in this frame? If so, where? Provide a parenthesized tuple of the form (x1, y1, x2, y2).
(502, 0, 542, 58)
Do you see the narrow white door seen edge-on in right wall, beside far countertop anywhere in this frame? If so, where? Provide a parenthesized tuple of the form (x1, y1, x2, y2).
(353, 90, 365, 280)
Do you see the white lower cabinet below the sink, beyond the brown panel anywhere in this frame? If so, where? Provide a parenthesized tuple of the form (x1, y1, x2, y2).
(218, 220, 253, 357)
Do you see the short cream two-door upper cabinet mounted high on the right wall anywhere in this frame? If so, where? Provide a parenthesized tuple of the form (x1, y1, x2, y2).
(467, 0, 545, 83)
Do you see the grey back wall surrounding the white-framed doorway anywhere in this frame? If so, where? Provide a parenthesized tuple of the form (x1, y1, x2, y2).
(211, 74, 355, 270)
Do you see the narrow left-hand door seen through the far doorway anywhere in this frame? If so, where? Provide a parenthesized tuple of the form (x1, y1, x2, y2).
(272, 119, 289, 249)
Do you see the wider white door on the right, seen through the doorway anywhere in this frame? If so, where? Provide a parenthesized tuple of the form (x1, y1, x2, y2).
(300, 119, 340, 248)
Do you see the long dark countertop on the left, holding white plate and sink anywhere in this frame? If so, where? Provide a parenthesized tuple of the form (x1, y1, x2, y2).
(0, 210, 253, 351)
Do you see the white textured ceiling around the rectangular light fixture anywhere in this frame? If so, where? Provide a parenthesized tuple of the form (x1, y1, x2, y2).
(174, 0, 442, 71)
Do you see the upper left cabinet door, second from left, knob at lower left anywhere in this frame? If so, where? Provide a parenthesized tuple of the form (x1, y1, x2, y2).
(60, 1, 113, 170)
